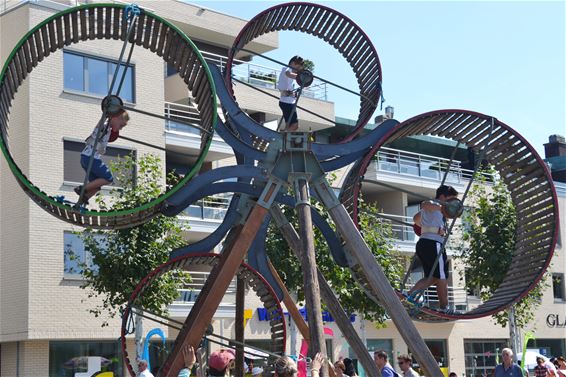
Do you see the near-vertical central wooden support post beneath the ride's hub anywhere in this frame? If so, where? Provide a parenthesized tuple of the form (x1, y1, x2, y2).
(295, 177, 328, 376)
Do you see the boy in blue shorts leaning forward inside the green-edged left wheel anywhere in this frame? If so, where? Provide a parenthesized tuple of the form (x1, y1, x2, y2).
(74, 110, 130, 204)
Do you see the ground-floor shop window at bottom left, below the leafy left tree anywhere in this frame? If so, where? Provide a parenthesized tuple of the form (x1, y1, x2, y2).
(49, 341, 123, 377)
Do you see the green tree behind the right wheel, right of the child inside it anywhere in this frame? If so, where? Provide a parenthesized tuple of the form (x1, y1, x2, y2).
(459, 171, 548, 327)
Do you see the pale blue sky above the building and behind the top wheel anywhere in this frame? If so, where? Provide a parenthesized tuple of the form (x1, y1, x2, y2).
(191, 1, 566, 154)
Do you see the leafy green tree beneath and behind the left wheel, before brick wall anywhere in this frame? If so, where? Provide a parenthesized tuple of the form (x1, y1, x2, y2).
(72, 154, 189, 326)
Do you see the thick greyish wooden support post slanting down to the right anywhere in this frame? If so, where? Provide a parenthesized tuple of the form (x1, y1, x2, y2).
(328, 204, 442, 376)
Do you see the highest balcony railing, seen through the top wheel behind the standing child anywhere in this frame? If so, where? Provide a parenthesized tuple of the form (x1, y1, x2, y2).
(202, 51, 328, 101)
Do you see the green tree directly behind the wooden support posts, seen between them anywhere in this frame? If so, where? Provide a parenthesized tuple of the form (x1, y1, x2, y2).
(266, 195, 404, 323)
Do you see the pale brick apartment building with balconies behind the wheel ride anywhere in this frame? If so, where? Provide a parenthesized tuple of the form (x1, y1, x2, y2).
(0, 0, 566, 377)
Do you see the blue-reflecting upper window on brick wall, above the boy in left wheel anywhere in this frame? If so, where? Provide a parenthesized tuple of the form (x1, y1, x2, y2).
(63, 51, 135, 103)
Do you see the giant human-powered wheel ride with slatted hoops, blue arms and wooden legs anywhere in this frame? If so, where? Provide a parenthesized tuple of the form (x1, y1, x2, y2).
(0, 3, 558, 377)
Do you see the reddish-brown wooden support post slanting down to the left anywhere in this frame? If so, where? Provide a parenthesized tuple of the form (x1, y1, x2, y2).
(158, 204, 267, 377)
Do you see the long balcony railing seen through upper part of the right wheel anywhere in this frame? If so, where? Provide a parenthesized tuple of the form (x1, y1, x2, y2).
(374, 148, 486, 183)
